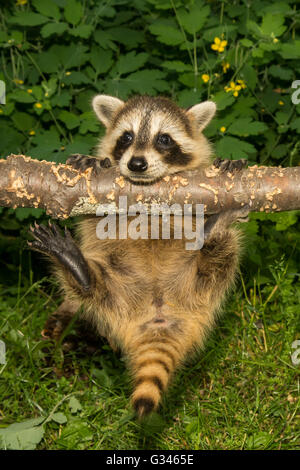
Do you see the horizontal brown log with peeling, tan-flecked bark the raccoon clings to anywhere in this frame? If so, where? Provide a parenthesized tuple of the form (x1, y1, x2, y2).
(0, 154, 300, 219)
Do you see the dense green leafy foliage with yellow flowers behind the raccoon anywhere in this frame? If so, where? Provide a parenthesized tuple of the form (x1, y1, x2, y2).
(0, 0, 300, 448)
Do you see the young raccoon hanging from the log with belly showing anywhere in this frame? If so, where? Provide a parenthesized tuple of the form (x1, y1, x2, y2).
(30, 95, 247, 417)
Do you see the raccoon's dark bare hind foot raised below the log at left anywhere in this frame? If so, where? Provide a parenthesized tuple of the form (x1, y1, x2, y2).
(28, 222, 91, 291)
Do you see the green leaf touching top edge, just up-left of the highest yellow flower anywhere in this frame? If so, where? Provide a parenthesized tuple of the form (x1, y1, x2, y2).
(178, 0, 210, 34)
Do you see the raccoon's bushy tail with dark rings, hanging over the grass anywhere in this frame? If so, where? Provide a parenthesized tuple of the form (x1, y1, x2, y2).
(131, 336, 183, 418)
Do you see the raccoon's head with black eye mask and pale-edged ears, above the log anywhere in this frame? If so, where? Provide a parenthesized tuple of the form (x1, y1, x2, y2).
(93, 95, 216, 184)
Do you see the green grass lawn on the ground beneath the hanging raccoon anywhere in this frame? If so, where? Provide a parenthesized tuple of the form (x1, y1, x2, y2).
(0, 252, 300, 450)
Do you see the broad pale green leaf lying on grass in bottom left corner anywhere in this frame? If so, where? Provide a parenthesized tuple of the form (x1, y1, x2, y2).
(0, 418, 45, 450)
